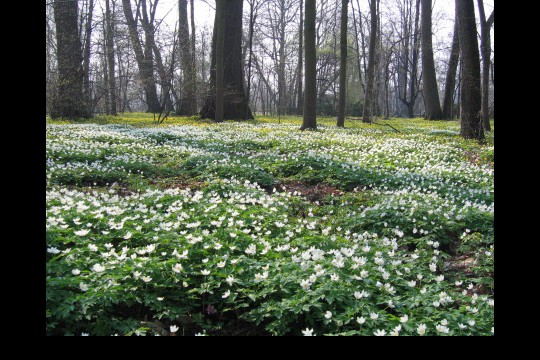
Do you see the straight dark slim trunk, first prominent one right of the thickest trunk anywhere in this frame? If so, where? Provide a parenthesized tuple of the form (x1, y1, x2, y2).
(300, 0, 316, 130)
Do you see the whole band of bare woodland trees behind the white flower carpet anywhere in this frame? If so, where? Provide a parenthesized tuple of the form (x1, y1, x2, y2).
(46, 0, 494, 140)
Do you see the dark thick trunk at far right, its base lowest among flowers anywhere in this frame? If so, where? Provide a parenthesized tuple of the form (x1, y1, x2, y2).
(456, 0, 484, 142)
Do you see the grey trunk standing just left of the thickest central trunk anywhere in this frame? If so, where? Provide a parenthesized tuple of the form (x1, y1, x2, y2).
(177, 0, 197, 116)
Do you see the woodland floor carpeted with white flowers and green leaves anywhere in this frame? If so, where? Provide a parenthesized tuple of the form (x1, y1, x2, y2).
(46, 113, 494, 336)
